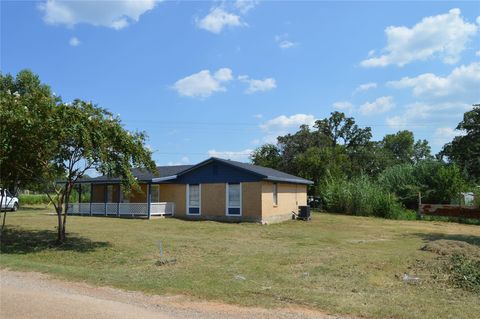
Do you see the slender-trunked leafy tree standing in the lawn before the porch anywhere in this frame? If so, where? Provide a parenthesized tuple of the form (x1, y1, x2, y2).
(51, 100, 155, 243)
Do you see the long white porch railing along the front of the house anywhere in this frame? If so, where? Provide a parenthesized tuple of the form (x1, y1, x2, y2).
(68, 202, 175, 217)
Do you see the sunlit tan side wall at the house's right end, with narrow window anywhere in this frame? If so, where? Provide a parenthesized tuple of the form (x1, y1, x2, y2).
(262, 182, 307, 220)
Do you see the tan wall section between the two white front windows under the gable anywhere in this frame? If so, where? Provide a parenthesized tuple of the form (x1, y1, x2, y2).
(200, 183, 226, 217)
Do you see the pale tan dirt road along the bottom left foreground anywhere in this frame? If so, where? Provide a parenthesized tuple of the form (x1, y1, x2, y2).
(0, 270, 348, 319)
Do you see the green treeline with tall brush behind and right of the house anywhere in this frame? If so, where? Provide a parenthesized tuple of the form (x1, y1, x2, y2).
(251, 109, 480, 218)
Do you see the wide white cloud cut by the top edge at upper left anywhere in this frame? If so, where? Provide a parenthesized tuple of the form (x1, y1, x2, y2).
(38, 0, 157, 30)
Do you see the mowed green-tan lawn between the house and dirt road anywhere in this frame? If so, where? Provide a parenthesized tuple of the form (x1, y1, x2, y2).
(0, 209, 480, 318)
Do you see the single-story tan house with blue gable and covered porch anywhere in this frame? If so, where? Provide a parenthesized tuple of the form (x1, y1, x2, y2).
(69, 157, 313, 223)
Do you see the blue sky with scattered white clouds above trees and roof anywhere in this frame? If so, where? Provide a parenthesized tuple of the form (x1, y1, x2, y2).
(0, 0, 480, 165)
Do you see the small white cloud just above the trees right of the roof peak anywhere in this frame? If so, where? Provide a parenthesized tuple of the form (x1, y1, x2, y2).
(260, 114, 315, 143)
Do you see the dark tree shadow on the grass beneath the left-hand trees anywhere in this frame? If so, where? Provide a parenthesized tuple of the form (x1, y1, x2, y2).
(0, 228, 110, 254)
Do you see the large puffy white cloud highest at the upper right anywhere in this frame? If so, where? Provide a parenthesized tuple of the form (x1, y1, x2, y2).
(361, 9, 478, 67)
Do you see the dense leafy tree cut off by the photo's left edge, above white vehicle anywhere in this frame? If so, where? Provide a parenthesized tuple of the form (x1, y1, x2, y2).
(0, 70, 60, 229)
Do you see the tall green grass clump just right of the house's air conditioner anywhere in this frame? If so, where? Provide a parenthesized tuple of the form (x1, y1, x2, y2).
(321, 176, 416, 219)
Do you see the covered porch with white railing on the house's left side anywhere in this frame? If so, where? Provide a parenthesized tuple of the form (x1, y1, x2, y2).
(68, 183, 175, 218)
